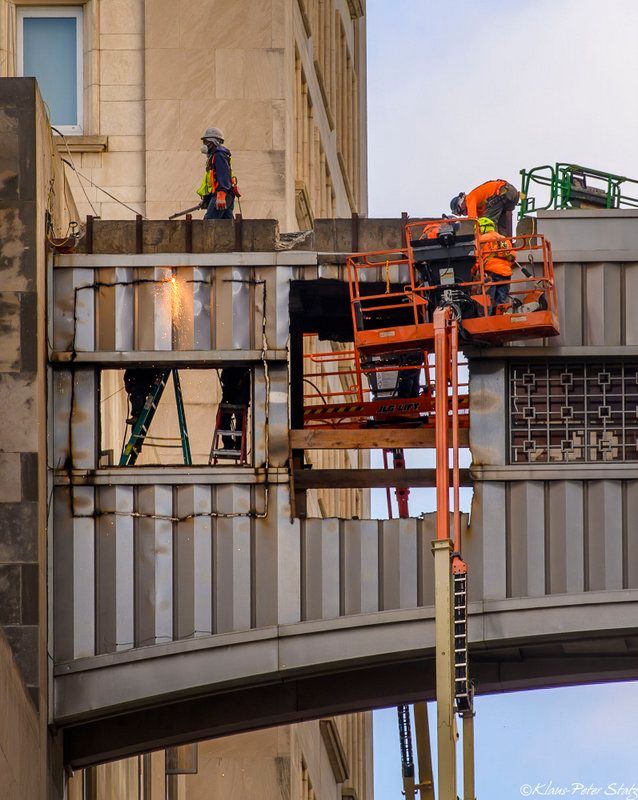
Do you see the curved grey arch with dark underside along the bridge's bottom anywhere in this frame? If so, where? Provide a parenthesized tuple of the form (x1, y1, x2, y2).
(54, 590, 638, 764)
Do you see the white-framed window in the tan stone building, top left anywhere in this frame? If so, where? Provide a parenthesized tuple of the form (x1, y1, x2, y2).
(18, 6, 84, 134)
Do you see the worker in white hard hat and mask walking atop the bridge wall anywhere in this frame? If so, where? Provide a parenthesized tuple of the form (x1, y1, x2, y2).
(197, 128, 240, 219)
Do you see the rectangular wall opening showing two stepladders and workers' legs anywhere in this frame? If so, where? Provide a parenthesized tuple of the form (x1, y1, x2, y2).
(99, 366, 253, 467)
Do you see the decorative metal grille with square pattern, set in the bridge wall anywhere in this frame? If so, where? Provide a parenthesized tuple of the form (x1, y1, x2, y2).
(510, 361, 638, 464)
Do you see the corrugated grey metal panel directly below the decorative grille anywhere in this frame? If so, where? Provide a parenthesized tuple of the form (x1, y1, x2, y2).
(464, 480, 638, 599)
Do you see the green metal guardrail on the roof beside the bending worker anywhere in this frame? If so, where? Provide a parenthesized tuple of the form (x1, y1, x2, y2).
(518, 164, 638, 219)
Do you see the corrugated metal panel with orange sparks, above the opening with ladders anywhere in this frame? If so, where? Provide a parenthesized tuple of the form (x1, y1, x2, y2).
(52, 266, 293, 352)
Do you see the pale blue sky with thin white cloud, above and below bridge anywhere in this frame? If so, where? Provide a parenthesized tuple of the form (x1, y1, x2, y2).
(367, 0, 638, 800)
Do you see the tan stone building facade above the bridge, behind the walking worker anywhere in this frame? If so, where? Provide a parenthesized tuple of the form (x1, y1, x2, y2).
(0, 0, 367, 230)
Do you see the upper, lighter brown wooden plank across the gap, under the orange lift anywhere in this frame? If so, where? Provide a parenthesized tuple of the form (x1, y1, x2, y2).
(290, 428, 469, 450)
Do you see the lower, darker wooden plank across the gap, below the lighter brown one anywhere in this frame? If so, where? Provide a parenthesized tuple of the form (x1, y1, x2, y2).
(294, 469, 472, 490)
